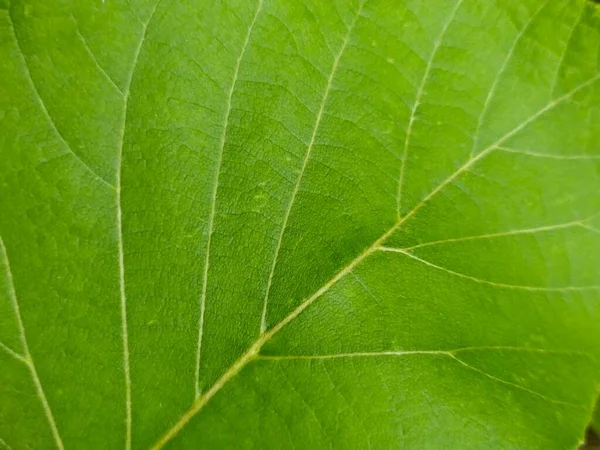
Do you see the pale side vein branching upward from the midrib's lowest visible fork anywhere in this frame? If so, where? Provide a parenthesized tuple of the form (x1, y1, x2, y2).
(194, 0, 262, 398)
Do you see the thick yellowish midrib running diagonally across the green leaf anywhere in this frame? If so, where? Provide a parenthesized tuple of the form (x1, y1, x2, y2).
(152, 68, 600, 450)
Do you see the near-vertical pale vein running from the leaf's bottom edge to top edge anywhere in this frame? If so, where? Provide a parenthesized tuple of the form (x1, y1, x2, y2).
(115, 0, 161, 450)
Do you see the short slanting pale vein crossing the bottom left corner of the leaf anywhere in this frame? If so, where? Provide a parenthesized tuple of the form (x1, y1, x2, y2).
(0, 237, 64, 450)
